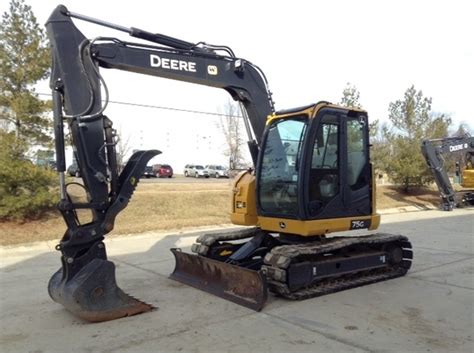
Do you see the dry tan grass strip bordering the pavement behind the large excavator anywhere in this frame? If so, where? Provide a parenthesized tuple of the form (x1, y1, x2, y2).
(0, 182, 439, 245)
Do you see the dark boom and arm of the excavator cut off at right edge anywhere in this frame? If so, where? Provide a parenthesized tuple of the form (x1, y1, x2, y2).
(421, 136, 474, 211)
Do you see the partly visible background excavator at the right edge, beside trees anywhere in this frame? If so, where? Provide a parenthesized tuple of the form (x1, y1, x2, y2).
(421, 136, 474, 211)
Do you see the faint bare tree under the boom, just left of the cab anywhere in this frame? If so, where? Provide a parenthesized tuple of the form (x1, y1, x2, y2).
(218, 100, 245, 169)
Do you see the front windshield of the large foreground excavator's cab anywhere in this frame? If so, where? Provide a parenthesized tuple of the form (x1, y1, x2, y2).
(258, 115, 308, 216)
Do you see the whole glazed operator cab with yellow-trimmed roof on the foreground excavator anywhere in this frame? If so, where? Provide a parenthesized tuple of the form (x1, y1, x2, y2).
(257, 103, 372, 220)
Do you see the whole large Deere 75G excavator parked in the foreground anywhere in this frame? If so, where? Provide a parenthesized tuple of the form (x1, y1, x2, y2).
(46, 5, 412, 321)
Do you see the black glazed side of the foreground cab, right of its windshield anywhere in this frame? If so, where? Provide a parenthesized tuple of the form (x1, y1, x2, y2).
(300, 108, 371, 219)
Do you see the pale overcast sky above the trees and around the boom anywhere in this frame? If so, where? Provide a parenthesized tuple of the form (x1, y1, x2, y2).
(0, 0, 474, 168)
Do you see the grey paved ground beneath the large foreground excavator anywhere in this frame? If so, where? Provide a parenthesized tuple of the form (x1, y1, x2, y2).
(0, 209, 474, 353)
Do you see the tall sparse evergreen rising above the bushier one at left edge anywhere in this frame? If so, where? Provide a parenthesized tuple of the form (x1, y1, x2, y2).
(0, 0, 51, 146)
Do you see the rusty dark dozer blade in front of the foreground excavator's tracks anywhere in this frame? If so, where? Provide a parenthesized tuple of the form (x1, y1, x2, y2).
(170, 249, 267, 311)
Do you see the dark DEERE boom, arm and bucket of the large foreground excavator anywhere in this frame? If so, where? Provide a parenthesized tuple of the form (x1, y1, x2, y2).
(46, 5, 274, 321)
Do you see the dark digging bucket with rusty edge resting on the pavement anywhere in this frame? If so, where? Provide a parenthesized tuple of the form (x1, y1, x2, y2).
(48, 259, 154, 322)
